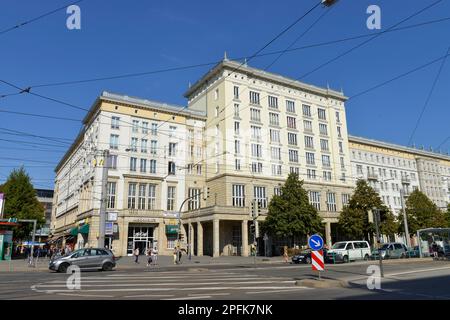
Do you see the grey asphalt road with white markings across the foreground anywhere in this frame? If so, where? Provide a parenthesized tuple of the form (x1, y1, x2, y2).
(0, 260, 450, 300)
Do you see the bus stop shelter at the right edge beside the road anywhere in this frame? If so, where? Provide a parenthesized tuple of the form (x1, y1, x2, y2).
(417, 228, 450, 258)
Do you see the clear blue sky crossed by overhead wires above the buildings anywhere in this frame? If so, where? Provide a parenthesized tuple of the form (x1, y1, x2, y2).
(0, 0, 450, 188)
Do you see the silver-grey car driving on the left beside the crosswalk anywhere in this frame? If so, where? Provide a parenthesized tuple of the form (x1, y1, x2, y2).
(48, 248, 116, 272)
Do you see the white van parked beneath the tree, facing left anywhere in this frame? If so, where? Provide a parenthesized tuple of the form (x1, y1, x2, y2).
(326, 241, 371, 263)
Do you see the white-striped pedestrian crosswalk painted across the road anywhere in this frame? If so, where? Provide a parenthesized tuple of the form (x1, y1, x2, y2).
(31, 270, 312, 300)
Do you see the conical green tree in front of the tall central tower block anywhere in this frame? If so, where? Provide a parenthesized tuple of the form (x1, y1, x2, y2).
(261, 173, 322, 242)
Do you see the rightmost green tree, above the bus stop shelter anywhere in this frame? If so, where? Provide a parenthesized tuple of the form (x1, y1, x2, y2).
(399, 190, 448, 233)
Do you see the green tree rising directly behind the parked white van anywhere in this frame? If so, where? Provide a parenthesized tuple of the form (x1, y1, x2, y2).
(338, 180, 398, 241)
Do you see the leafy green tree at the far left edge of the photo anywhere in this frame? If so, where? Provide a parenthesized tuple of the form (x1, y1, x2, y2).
(1, 167, 45, 239)
